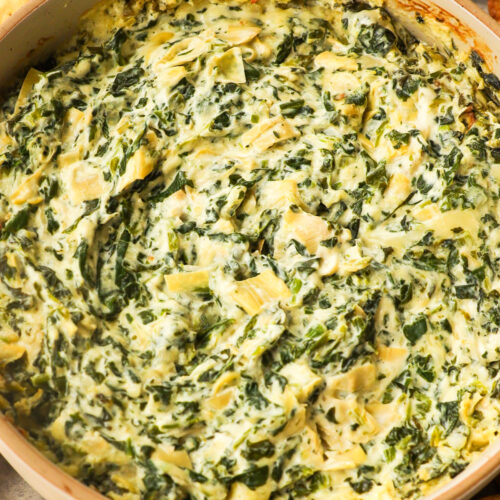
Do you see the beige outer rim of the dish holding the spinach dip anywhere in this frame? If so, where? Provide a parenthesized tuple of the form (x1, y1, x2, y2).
(0, 0, 500, 500)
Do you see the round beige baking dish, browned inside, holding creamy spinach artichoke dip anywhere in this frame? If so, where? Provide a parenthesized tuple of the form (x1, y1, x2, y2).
(0, 0, 500, 500)
